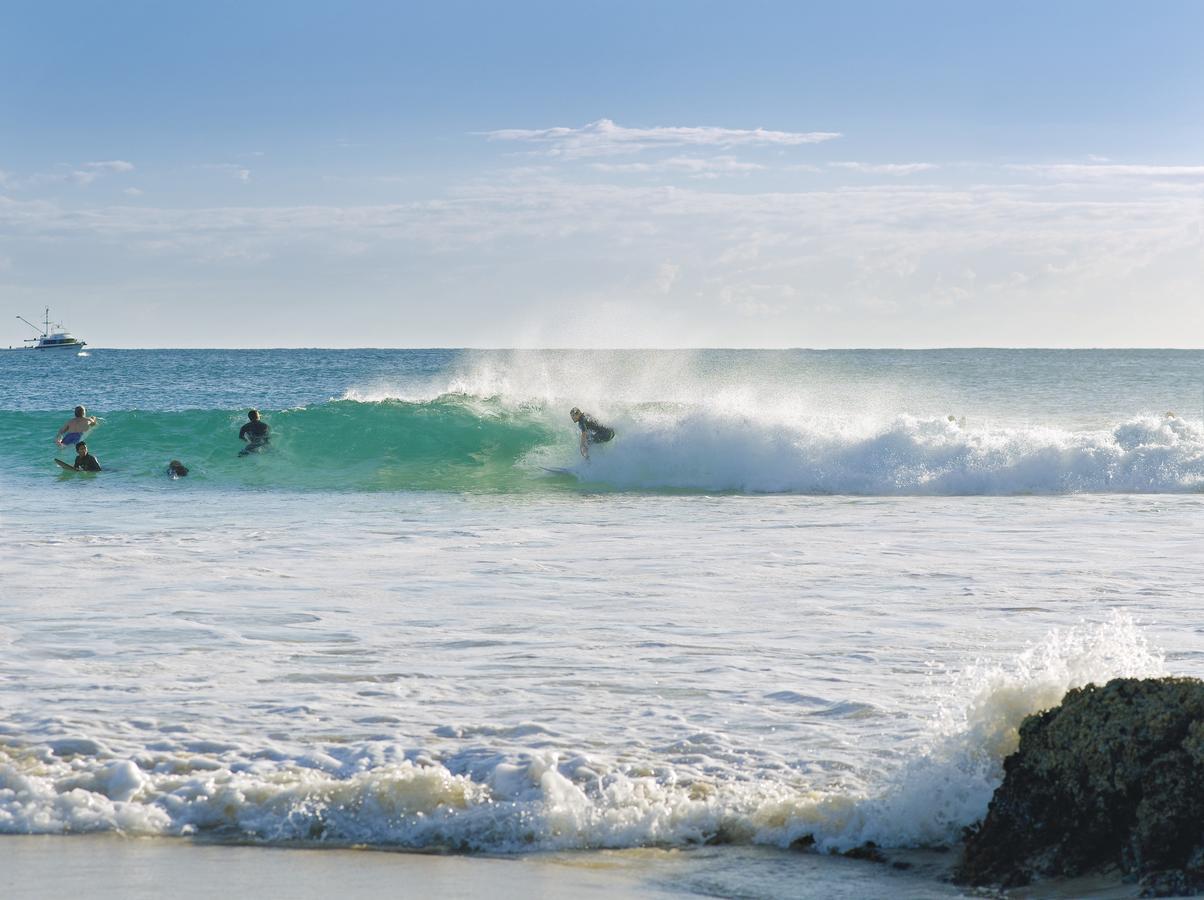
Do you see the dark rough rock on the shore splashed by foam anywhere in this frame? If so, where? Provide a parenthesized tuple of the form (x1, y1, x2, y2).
(955, 679, 1204, 896)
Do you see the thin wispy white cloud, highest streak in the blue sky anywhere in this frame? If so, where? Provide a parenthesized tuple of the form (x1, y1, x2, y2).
(484, 119, 840, 159)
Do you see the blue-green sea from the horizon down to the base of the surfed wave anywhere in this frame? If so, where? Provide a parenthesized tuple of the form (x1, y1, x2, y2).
(0, 350, 1204, 496)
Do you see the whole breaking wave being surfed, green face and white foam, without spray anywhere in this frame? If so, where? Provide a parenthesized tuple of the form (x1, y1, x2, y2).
(0, 393, 1204, 496)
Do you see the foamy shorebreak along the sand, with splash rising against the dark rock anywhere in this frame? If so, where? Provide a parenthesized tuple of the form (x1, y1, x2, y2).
(0, 615, 1164, 852)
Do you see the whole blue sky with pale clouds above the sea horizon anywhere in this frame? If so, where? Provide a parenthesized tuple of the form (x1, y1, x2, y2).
(0, 0, 1204, 348)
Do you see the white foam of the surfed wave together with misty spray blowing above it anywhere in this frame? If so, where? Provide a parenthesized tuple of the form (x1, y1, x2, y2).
(344, 351, 1204, 496)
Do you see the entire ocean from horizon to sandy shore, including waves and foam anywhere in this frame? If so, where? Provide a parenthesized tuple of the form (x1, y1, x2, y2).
(0, 349, 1204, 898)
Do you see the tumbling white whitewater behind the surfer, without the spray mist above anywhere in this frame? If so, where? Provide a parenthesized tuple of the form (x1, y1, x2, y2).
(551, 410, 1204, 496)
